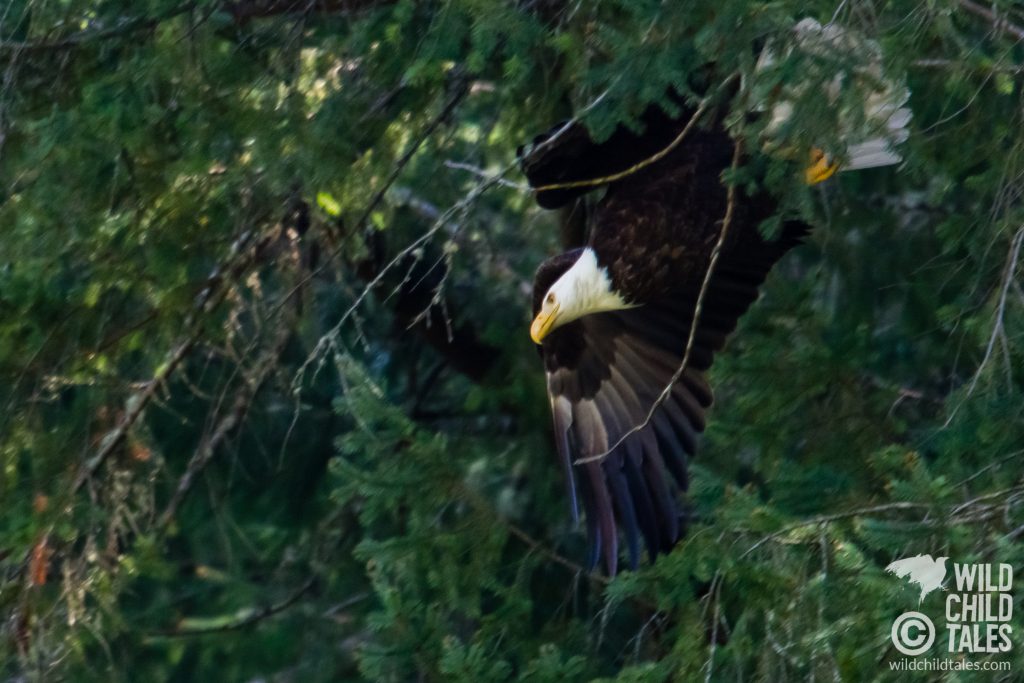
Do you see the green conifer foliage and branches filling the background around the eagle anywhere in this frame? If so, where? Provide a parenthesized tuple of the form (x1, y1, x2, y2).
(0, 0, 1024, 683)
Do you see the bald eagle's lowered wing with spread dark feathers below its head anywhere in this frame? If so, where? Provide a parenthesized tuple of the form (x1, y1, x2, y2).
(543, 223, 806, 573)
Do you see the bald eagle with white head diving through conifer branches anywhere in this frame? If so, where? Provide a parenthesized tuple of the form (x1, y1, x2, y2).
(520, 22, 909, 574)
